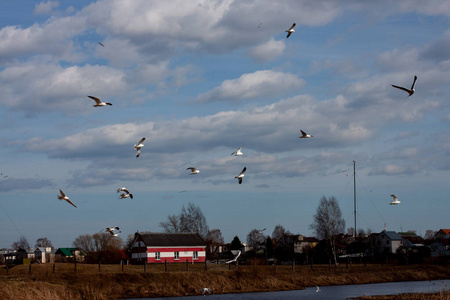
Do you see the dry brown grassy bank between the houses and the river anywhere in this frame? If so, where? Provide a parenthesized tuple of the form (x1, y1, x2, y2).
(0, 264, 450, 300)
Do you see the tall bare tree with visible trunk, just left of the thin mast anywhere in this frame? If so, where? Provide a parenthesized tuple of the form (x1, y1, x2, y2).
(309, 196, 345, 264)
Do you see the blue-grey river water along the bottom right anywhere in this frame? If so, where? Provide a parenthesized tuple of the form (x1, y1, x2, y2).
(128, 280, 450, 300)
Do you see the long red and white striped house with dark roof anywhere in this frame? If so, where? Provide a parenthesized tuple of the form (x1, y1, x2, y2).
(131, 232, 206, 264)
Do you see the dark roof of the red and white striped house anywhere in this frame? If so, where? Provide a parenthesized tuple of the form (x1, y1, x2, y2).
(137, 233, 206, 246)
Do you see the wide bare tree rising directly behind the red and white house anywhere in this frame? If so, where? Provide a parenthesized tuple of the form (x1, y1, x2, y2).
(159, 203, 209, 238)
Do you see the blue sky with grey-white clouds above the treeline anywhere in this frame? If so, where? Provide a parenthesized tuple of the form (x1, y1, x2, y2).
(0, 0, 450, 248)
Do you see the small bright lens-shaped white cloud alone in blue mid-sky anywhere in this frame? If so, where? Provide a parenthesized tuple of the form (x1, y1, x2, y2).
(196, 70, 305, 103)
